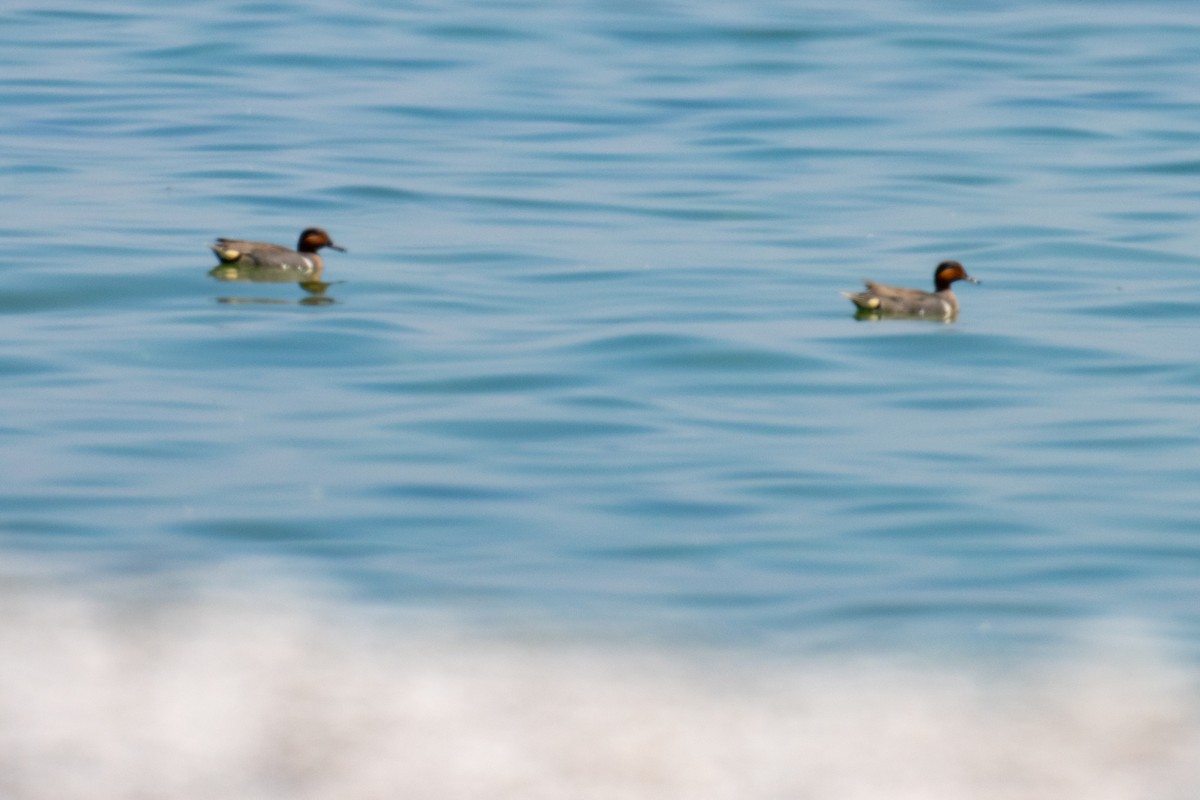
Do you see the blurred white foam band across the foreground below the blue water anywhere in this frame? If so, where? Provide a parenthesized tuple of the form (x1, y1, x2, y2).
(0, 568, 1200, 800)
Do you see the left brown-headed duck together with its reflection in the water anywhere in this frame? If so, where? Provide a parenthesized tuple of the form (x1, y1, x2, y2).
(209, 228, 346, 306)
